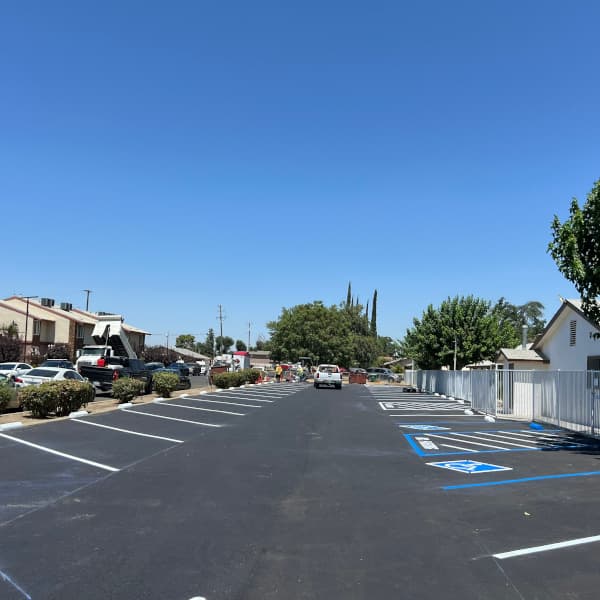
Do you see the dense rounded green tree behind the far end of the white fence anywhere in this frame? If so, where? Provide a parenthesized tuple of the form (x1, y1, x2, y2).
(402, 296, 506, 369)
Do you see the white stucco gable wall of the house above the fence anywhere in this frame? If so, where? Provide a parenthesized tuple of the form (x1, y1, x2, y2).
(540, 307, 600, 371)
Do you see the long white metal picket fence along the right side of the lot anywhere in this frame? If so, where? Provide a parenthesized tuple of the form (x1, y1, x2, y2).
(404, 369, 600, 435)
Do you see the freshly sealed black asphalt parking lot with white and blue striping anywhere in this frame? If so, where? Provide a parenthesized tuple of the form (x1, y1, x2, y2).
(0, 384, 600, 600)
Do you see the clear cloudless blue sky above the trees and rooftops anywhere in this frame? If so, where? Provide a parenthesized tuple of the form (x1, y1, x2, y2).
(0, 0, 600, 344)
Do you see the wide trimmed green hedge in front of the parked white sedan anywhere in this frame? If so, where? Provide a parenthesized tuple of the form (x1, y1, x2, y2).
(19, 381, 94, 419)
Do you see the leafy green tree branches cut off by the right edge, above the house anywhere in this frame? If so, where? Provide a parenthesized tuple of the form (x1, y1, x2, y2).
(548, 179, 600, 323)
